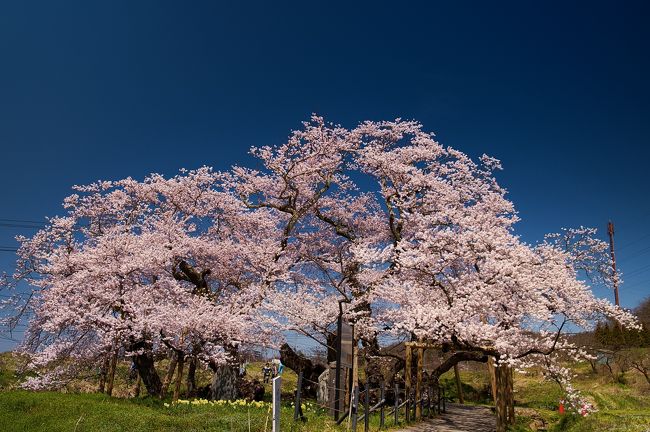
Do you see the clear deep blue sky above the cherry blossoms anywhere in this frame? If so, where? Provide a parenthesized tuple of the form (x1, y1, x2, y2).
(0, 1, 650, 347)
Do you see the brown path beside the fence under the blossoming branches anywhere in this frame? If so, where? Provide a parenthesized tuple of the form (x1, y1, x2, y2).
(392, 404, 496, 432)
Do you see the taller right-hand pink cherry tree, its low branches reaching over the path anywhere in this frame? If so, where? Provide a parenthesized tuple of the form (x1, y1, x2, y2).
(234, 118, 634, 422)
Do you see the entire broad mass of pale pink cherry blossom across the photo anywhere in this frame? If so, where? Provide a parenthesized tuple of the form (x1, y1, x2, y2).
(2, 116, 635, 422)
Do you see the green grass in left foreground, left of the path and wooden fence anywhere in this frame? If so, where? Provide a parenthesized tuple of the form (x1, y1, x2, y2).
(0, 390, 404, 432)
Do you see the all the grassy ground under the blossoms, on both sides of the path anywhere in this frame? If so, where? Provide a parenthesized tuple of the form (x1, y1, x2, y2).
(0, 355, 650, 432)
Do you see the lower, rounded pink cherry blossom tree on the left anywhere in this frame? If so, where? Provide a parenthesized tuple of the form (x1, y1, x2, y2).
(6, 168, 280, 394)
